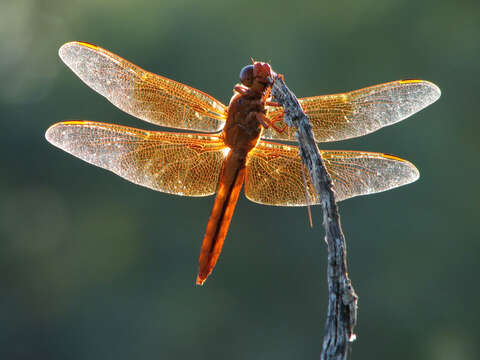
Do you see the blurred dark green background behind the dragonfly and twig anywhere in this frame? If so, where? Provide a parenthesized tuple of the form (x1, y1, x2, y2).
(0, 0, 480, 360)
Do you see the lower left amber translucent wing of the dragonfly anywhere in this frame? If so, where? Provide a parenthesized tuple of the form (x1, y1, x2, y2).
(45, 121, 226, 196)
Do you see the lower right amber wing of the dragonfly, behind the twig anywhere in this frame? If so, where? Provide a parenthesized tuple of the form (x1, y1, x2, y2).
(245, 141, 419, 206)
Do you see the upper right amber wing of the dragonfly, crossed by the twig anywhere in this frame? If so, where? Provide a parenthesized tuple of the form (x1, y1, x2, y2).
(262, 80, 440, 142)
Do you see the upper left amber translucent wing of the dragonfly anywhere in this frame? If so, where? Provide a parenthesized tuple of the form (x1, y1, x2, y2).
(59, 42, 227, 132)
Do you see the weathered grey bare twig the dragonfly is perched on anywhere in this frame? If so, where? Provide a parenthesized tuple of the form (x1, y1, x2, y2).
(271, 77, 357, 360)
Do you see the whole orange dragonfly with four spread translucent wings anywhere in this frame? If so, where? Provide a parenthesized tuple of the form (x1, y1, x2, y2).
(45, 41, 440, 285)
